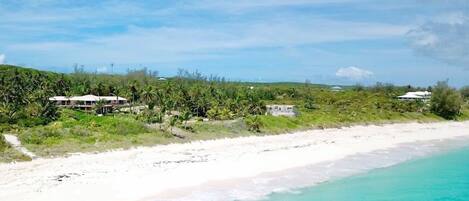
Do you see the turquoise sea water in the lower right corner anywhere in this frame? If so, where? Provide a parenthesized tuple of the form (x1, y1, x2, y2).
(266, 148, 469, 201)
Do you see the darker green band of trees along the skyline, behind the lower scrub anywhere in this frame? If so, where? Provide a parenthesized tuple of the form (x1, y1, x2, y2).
(0, 65, 469, 126)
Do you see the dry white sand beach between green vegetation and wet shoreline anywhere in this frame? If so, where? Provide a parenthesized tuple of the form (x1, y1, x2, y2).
(0, 122, 469, 201)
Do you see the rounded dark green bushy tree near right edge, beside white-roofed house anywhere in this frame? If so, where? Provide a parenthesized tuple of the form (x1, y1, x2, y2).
(431, 82, 463, 119)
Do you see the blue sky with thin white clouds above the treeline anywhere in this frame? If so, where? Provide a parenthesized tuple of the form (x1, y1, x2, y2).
(0, 0, 469, 87)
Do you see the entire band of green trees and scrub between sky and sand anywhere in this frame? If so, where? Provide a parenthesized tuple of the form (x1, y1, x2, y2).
(0, 65, 469, 161)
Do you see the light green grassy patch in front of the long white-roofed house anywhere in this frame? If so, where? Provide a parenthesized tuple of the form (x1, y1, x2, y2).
(18, 110, 178, 157)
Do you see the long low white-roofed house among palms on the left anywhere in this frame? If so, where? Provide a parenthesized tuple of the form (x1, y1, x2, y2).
(49, 94, 127, 112)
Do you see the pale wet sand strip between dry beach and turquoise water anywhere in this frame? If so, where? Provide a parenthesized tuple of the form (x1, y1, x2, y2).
(153, 137, 469, 201)
